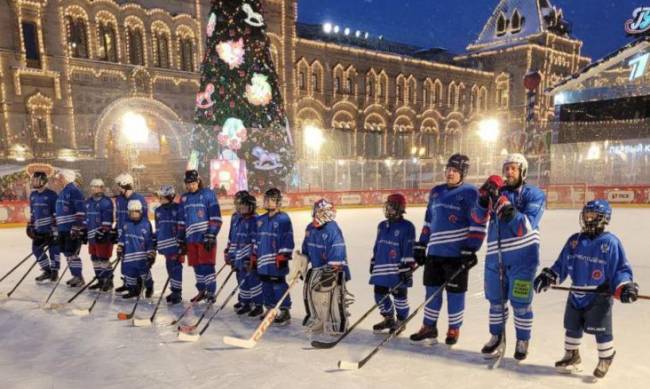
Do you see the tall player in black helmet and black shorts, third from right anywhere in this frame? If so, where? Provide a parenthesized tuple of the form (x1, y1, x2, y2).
(410, 154, 487, 346)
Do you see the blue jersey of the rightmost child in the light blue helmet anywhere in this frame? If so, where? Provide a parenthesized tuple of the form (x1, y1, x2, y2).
(551, 232, 632, 309)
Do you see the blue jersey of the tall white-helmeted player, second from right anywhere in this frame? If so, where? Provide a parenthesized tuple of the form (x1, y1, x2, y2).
(486, 184, 545, 270)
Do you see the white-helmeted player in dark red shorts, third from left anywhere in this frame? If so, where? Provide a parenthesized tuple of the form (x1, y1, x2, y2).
(86, 178, 113, 292)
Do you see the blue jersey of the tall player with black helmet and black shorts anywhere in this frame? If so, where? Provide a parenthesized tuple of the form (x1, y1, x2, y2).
(420, 183, 487, 258)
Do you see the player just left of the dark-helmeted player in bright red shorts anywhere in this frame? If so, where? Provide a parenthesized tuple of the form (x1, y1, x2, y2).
(154, 185, 185, 304)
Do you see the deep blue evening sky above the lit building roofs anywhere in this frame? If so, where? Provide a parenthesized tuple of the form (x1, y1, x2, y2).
(298, 0, 650, 60)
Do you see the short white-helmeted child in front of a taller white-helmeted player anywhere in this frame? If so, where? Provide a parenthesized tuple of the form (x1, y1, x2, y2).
(117, 200, 156, 299)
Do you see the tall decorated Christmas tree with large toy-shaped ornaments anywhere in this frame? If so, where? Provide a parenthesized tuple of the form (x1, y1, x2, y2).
(189, 0, 294, 193)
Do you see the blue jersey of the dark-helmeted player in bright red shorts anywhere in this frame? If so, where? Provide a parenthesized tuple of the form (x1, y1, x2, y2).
(178, 188, 221, 243)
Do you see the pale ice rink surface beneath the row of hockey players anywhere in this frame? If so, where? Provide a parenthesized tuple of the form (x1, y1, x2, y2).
(0, 208, 650, 389)
